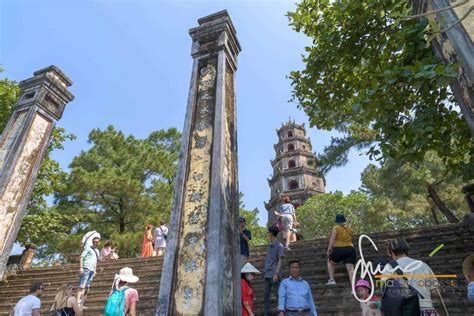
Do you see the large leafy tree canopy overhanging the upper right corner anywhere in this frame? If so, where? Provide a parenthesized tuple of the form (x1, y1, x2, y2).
(288, 0, 474, 180)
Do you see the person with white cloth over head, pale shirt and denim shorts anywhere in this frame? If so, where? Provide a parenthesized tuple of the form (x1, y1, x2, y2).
(76, 232, 100, 308)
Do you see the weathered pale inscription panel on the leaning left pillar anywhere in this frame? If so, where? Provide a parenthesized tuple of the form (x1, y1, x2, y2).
(0, 114, 52, 251)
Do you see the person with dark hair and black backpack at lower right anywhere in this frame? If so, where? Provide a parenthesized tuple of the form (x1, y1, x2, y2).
(382, 237, 439, 316)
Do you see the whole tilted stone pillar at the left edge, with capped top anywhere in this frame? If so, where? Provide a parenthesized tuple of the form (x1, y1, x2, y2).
(0, 66, 74, 279)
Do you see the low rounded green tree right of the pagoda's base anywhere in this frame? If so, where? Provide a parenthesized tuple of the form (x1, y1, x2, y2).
(296, 191, 385, 239)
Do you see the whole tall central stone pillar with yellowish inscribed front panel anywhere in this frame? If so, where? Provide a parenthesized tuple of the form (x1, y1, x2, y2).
(156, 10, 241, 315)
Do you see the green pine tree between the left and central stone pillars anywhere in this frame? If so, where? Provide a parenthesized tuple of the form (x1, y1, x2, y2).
(50, 126, 180, 257)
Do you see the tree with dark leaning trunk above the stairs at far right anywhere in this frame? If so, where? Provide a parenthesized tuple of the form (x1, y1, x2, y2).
(361, 152, 468, 228)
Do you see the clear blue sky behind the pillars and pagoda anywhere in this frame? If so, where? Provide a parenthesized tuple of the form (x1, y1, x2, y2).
(0, 0, 369, 231)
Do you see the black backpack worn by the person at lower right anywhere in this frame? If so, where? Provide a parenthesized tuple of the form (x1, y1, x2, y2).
(382, 261, 424, 316)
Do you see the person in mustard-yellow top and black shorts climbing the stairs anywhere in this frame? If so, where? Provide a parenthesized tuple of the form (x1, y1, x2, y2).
(326, 214, 356, 285)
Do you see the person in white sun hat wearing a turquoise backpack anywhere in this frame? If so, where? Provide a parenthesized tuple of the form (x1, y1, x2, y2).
(104, 267, 139, 316)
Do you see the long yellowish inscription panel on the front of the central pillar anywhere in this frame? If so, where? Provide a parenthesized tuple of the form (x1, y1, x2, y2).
(174, 60, 216, 315)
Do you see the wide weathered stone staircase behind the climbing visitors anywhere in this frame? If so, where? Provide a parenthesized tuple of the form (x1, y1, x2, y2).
(0, 225, 474, 316)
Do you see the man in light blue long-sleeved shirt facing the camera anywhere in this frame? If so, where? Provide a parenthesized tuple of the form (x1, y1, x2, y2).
(278, 260, 318, 316)
